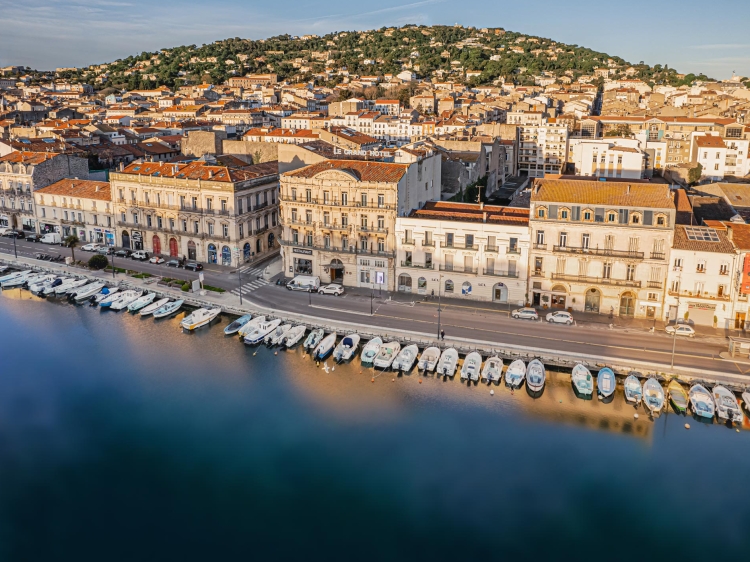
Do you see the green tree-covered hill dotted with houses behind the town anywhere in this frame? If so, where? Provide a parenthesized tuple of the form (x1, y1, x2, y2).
(58, 25, 706, 90)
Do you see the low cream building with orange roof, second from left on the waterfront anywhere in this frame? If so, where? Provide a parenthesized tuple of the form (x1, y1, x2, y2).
(34, 179, 115, 245)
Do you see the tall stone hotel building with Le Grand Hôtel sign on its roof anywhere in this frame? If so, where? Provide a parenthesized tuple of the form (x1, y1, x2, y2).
(280, 154, 440, 290)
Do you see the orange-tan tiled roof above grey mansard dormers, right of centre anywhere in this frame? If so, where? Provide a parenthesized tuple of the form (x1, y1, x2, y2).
(531, 179, 674, 209)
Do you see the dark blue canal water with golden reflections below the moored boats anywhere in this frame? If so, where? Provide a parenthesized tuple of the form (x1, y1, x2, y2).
(0, 290, 750, 561)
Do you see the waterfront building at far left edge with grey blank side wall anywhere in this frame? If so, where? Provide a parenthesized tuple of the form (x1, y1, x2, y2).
(0, 151, 89, 231)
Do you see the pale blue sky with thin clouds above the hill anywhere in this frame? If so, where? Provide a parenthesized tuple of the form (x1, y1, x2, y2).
(0, 0, 750, 79)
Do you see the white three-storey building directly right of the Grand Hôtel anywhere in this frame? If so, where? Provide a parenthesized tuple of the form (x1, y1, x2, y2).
(396, 202, 530, 306)
